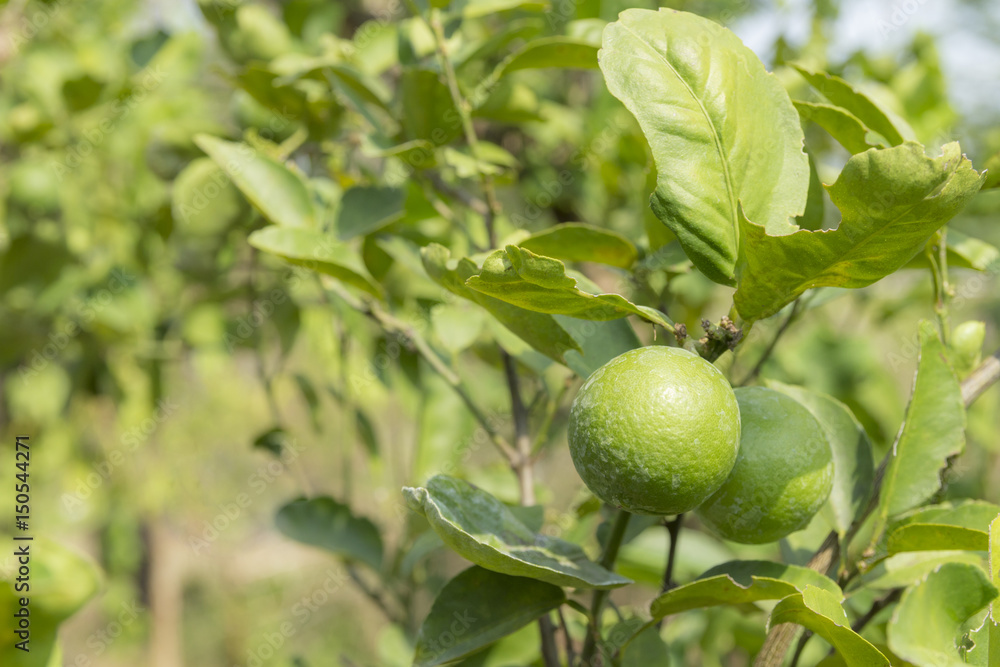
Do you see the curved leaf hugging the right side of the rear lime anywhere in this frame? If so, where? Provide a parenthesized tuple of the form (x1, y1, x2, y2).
(766, 381, 875, 538)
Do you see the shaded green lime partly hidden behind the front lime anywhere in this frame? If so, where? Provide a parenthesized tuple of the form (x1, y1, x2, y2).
(697, 387, 833, 544)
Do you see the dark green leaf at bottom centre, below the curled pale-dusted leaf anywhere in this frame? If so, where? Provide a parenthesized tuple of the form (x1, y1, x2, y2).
(413, 566, 566, 667)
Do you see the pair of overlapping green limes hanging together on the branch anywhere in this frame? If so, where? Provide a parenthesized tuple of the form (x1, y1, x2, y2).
(569, 346, 833, 544)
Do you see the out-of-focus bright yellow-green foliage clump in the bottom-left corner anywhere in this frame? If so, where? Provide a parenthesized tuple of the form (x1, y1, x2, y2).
(0, 538, 102, 667)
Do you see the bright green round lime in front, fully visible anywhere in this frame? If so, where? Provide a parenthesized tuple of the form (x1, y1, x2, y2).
(569, 346, 740, 514)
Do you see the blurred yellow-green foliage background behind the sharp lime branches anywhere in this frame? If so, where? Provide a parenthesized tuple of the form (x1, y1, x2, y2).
(0, 0, 1000, 667)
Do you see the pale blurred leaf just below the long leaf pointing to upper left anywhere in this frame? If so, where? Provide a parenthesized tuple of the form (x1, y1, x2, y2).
(247, 225, 382, 297)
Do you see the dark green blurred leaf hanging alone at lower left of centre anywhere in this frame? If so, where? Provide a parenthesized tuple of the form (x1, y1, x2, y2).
(275, 496, 382, 571)
